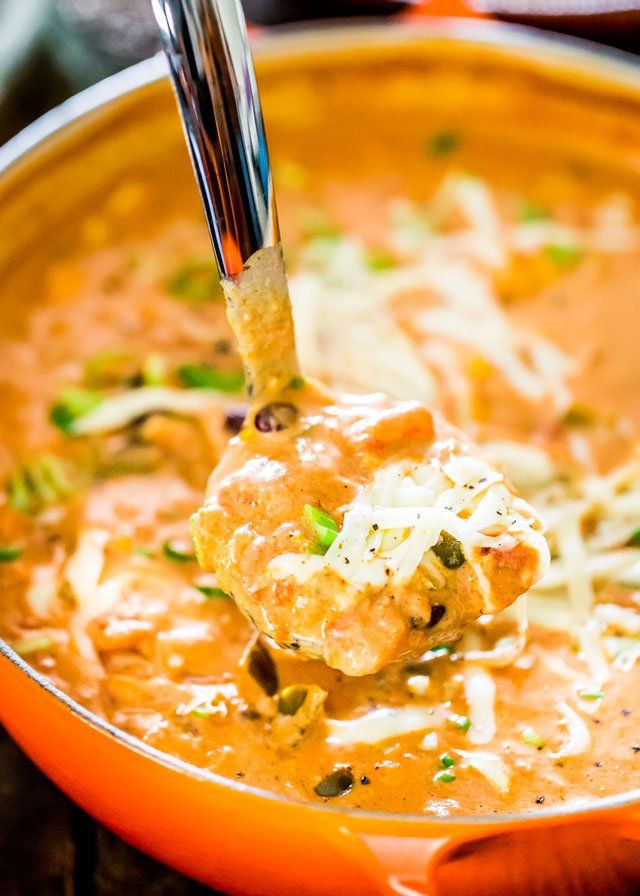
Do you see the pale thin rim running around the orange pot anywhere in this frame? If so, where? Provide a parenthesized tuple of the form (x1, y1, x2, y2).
(0, 18, 640, 829)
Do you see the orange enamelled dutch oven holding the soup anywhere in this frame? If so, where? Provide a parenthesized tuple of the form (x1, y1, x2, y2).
(0, 21, 640, 896)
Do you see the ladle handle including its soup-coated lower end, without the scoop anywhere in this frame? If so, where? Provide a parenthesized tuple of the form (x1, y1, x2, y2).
(153, 0, 298, 406)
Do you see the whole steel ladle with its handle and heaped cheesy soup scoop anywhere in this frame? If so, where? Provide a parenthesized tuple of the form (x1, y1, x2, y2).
(156, 0, 549, 675)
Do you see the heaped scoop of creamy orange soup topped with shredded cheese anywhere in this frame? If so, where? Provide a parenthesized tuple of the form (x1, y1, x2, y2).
(192, 378, 548, 675)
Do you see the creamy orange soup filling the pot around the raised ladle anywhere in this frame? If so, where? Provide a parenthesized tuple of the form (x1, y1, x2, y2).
(0, 49, 640, 815)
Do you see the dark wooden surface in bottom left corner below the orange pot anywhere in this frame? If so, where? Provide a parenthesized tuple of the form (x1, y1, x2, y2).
(0, 728, 220, 896)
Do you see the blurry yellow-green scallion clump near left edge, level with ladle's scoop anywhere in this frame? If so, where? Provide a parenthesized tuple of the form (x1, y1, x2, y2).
(7, 454, 77, 513)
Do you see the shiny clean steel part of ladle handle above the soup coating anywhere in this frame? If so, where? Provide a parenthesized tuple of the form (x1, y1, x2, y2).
(152, 0, 280, 279)
